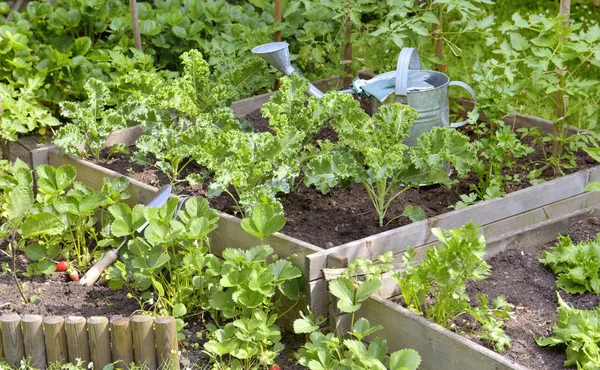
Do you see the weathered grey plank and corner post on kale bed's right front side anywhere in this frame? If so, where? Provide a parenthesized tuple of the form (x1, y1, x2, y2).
(306, 166, 600, 315)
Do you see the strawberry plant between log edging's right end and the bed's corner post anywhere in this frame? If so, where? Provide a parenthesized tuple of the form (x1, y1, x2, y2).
(204, 245, 302, 369)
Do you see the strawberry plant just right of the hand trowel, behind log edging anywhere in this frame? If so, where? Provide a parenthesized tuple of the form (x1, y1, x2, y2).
(107, 198, 220, 328)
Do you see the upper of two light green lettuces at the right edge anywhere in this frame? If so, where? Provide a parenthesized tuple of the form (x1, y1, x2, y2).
(539, 235, 600, 294)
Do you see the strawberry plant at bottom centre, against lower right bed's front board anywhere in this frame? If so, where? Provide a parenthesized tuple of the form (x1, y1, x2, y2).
(294, 252, 421, 370)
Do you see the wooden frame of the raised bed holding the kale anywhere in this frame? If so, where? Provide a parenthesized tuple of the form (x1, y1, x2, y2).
(19, 112, 600, 315)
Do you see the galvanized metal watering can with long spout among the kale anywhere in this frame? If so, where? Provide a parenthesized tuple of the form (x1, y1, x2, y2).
(252, 42, 477, 146)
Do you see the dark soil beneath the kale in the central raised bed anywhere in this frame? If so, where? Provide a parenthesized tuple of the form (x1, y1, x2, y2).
(91, 102, 595, 248)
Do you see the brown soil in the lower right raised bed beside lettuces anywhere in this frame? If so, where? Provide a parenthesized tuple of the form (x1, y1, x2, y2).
(459, 215, 600, 370)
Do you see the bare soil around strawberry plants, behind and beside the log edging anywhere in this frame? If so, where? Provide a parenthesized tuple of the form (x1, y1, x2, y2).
(0, 251, 305, 370)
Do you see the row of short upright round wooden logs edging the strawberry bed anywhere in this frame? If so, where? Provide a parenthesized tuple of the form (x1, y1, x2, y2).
(0, 313, 179, 370)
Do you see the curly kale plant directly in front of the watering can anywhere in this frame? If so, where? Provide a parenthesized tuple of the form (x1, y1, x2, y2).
(304, 93, 475, 226)
